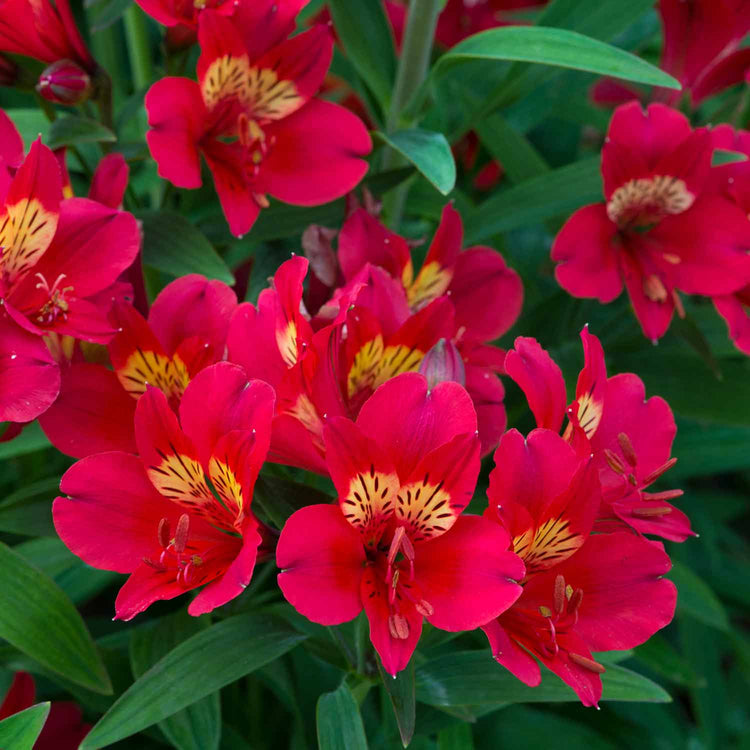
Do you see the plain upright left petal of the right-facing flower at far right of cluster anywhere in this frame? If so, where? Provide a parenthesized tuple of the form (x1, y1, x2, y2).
(505, 336, 566, 432)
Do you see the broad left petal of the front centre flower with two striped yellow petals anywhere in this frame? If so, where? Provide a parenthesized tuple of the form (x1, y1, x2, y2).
(276, 505, 365, 625)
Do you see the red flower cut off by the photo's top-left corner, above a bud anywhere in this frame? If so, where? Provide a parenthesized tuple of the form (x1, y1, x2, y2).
(0, 0, 97, 73)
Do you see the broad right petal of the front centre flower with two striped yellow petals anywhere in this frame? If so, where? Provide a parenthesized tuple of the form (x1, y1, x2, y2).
(414, 516, 524, 631)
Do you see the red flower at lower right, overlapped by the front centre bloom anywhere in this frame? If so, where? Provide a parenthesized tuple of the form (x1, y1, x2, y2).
(482, 429, 677, 706)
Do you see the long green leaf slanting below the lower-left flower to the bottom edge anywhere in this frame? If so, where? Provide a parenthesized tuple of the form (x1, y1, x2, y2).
(81, 615, 304, 750)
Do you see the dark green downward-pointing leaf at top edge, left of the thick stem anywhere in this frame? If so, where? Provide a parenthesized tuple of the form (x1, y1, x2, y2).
(328, 0, 396, 110)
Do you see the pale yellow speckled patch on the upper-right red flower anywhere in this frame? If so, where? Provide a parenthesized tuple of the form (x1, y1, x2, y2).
(607, 175, 695, 229)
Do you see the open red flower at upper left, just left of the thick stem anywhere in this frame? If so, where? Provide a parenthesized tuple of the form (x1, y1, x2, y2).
(146, 5, 372, 235)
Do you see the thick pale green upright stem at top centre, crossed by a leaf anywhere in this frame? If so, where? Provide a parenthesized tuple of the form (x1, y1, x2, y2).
(383, 0, 442, 229)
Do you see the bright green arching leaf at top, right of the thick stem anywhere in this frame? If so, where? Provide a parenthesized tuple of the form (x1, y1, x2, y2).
(433, 26, 680, 89)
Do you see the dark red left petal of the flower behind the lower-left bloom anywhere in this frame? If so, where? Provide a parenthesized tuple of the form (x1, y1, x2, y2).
(39, 362, 136, 458)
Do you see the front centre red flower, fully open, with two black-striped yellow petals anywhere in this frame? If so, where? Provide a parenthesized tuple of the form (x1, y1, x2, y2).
(276, 373, 524, 675)
